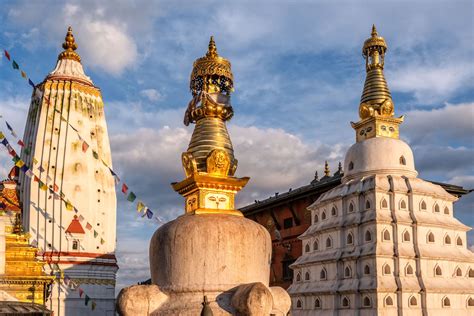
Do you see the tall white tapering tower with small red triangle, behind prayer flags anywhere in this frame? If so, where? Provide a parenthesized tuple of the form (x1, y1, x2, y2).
(20, 28, 118, 316)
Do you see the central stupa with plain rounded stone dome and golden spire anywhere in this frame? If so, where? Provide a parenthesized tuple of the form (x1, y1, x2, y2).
(118, 37, 291, 315)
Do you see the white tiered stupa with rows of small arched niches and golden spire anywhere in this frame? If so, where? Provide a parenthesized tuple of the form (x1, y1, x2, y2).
(288, 27, 474, 316)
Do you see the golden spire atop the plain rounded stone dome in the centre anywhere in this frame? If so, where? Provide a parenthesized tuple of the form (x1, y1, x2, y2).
(173, 36, 249, 216)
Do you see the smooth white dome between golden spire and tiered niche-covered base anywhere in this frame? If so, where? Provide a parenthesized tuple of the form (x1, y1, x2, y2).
(343, 137, 418, 182)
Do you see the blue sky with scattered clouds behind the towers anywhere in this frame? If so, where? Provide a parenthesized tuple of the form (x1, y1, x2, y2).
(0, 0, 474, 288)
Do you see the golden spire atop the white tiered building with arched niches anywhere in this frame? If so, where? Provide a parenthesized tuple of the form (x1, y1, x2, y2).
(352, 24, 403, 141)
